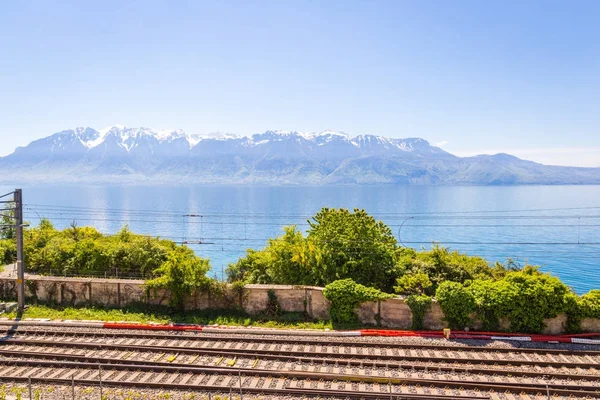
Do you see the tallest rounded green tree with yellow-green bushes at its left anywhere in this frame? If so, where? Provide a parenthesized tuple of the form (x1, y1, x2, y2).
(227, 208, 399, 291)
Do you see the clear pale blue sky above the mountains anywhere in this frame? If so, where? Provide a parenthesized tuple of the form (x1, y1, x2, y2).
(0, 0, 600, 166)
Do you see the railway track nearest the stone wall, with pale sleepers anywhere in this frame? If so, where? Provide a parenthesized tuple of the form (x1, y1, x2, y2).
(0, 331, 600, 369)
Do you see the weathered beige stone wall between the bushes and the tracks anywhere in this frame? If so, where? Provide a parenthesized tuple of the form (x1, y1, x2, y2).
(0, 275, 600, 334)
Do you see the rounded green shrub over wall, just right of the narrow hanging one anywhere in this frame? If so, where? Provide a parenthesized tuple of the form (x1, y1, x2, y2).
(435, 281, 476, 329)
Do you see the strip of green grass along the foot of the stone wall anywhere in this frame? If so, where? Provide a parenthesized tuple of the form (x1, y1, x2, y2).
(7, 305, 346, 329)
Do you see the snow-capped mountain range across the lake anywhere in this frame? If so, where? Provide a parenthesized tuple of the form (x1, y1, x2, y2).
(0, 126, 600, 185)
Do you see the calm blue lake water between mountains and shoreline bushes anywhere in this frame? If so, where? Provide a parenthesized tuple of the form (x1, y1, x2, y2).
(0, 186, 600, 293)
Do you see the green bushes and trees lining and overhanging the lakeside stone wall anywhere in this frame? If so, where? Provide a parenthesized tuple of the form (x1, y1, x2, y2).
(0, 208, 600, 333)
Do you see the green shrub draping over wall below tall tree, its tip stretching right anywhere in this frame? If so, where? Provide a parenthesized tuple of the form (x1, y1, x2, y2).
(323, 279, 394, 323)
